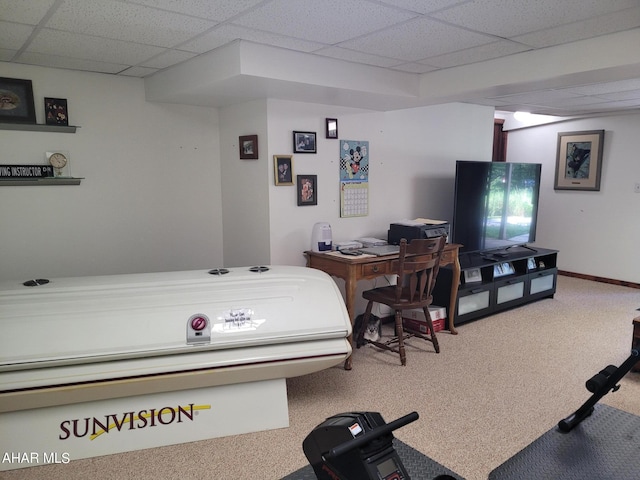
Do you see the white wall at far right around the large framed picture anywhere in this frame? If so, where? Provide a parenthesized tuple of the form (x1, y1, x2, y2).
(507, 113, 640, 283)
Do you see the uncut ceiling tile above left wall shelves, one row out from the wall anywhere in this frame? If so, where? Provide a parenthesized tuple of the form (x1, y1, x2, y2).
(27, 28, 165, 65)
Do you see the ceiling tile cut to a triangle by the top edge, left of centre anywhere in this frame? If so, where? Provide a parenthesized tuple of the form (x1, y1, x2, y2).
(132, 0, 263, 22)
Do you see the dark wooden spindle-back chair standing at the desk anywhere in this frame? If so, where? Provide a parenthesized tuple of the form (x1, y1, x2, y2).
(356, 237, 446, 365)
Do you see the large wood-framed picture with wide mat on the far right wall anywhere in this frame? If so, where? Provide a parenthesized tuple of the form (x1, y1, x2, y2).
(553, 130, 604, 191)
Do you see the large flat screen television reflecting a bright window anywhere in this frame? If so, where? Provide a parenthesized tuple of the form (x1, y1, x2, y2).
(451, 160, 542, 252)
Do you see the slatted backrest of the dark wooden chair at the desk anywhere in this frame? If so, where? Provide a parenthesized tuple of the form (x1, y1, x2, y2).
(396, 236, 446, 303)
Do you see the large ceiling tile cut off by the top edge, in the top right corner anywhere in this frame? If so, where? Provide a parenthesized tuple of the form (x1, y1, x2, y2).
(433, 0, 638, 37)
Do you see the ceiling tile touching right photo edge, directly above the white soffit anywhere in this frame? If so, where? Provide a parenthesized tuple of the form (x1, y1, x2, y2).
(511, 7, 640, 48)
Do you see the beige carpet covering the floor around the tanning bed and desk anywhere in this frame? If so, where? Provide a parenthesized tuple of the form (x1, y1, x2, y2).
(5, 277, 640, 480)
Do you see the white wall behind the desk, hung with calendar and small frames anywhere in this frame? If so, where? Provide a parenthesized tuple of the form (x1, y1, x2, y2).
(269, 100, 493, 265)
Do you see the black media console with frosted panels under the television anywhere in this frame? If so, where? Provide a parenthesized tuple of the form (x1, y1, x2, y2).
(433, 246, 558, 326)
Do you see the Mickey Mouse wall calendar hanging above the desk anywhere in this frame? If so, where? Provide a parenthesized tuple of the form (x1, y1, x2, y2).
(340, 140, 369, 217)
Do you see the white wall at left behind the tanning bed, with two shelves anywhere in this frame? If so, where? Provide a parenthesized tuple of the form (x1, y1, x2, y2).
(0, 63, 222, 280)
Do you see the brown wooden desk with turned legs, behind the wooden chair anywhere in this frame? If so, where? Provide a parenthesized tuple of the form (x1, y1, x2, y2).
(305, 243, 460, 370)
